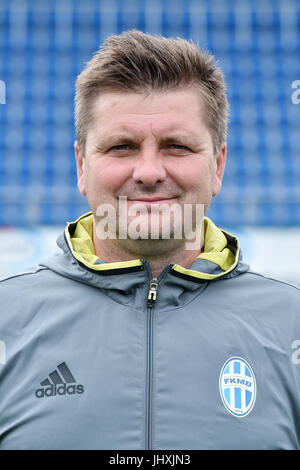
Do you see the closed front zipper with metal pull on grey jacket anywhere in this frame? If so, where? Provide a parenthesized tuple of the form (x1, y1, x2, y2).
(145, 277, 158, 450)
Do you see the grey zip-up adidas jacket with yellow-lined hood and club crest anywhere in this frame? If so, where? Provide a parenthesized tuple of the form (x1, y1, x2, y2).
(0, 214, 300, 449)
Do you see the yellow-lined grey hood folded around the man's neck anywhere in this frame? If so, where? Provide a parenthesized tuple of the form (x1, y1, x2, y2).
(42, 212, 249, 284)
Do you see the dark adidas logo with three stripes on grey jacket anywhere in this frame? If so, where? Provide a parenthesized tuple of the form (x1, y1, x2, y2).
(35, 362, 84, 398)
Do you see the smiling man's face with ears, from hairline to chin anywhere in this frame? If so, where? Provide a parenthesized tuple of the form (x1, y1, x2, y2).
(75, 89, 226, 258)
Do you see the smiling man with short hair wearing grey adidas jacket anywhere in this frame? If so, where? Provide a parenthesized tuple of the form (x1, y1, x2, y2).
(0, 31, 300, 449)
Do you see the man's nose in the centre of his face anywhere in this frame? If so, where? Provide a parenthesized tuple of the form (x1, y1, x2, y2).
(132, 149, 167, 187)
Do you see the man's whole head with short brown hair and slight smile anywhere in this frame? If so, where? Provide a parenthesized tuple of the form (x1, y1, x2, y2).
(75, 31, 227, 257)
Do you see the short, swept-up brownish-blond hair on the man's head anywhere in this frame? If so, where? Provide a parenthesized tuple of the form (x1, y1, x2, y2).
(75, 30, 228, 153)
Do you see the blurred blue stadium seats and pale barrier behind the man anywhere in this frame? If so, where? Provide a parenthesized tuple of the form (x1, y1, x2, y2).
(0, 0, 300, 285)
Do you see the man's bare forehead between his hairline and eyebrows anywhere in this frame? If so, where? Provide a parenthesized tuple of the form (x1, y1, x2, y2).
(90, 89, 206, 133)
